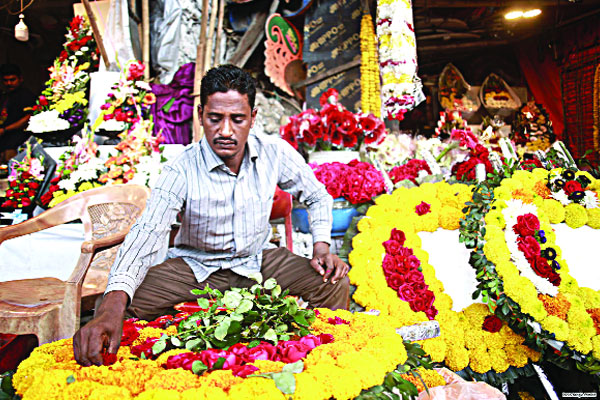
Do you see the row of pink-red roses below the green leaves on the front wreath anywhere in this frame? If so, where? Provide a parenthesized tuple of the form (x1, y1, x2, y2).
(163, 334, 334, 377)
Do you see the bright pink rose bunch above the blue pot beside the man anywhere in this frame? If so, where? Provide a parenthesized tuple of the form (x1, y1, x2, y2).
(311, 160, 385, 204)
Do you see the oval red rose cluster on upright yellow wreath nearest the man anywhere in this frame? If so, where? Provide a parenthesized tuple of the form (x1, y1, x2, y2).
(383, 228, 438, 320)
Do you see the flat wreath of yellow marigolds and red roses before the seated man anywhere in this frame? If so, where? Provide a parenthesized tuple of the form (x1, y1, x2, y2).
(13, 309, 407, 400)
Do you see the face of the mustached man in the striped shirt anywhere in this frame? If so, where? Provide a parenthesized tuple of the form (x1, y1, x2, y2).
(200, 90, 256, 173)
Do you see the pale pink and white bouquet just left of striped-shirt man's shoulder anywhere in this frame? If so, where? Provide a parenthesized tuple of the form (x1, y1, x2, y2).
(98, 120, 166, 186)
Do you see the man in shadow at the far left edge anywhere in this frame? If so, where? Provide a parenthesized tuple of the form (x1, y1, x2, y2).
(0, 64, 35, 163)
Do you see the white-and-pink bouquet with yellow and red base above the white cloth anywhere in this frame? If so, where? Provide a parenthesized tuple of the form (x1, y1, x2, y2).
(40, 131, 106, 207)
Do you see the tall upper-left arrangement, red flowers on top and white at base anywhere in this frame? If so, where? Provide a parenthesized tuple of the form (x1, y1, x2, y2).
(27, 16, 99, 134)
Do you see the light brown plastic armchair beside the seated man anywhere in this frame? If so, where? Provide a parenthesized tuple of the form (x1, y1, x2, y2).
(0, 185, 150, 344)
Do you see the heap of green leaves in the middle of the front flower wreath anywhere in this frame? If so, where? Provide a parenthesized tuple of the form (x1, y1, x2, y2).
(152, 277, 315, 360)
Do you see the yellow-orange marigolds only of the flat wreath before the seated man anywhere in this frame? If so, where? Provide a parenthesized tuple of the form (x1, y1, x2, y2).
(13, 309, 407, 400)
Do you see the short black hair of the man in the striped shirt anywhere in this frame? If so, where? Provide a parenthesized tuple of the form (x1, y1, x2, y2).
(200, 64, 256, 109)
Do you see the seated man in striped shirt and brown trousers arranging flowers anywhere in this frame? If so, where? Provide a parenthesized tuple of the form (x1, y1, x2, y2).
(73, 65, 349, 366)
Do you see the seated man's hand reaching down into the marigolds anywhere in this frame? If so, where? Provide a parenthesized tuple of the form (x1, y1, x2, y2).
(73, 291, 128, 367)
